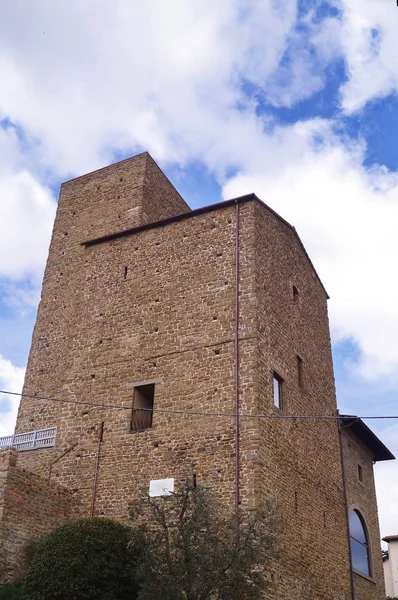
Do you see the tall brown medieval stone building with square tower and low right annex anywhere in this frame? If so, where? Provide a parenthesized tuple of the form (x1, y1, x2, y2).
(0, 153, 391, 600)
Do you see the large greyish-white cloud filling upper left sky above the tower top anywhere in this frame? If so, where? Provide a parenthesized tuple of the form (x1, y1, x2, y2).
(0, 0, 333, 177)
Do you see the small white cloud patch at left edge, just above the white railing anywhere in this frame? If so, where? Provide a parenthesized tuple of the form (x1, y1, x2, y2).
(0, 355, 25, 437)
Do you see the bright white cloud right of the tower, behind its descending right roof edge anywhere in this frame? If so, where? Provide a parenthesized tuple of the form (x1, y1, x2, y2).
(224, 121, 398, 380)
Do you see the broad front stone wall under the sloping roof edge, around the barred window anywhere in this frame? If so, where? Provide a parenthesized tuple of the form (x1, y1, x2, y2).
(18, 198, 255, 519)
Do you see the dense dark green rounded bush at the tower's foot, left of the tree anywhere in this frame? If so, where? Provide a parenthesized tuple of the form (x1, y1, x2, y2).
(21, 518, 143, 600)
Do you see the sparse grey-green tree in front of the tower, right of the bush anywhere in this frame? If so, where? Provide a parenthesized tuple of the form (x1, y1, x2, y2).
(131, 486, 280, 600)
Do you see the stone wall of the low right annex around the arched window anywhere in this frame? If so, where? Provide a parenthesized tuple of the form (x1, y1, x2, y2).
(343, 428, 385, 600)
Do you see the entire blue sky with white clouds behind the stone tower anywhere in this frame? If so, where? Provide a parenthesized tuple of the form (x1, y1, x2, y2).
(0, 0, 398, 535)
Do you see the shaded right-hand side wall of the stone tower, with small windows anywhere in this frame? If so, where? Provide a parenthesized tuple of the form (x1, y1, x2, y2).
(256, 205, 350, 600)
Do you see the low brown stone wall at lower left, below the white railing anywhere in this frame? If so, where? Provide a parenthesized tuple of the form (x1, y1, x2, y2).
(0, 448, 72, 584)
